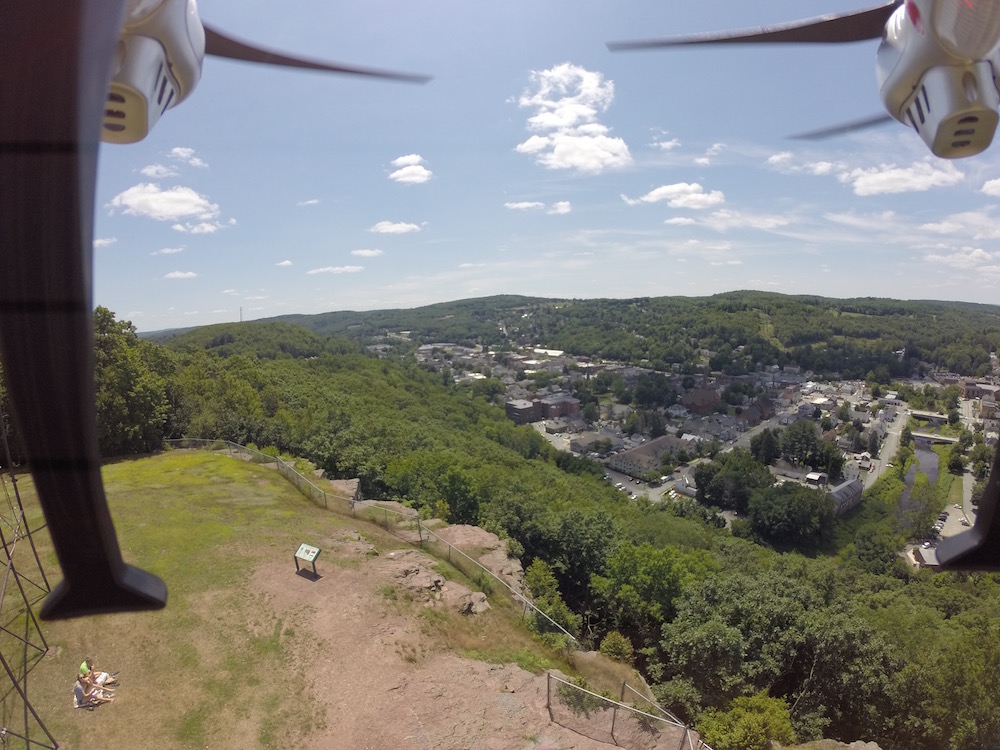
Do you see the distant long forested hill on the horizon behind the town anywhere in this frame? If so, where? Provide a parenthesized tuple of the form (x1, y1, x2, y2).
(150, 291, 1000, 378)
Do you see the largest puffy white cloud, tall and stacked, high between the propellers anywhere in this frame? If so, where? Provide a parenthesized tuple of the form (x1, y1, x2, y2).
(516, 62, 632, 174)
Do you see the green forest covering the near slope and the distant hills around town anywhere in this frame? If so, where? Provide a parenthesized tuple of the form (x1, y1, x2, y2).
(5, 302, 1000, 750)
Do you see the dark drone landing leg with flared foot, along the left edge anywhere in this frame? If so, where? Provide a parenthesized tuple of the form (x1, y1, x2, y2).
(0, 0, 167, 619)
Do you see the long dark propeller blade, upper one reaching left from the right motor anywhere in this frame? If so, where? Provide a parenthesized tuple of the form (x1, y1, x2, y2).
(608, 0, 900, 52)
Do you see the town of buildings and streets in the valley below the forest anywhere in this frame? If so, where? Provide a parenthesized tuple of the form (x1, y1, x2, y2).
(416, 343, 1000, 554)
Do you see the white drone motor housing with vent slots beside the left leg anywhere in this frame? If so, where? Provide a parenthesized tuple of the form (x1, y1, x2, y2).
(101, 0, 205, 143)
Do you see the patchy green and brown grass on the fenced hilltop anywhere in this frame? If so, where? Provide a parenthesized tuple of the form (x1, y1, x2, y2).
(0, 451, 588, 750)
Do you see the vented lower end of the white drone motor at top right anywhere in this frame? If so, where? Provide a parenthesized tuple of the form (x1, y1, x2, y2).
(900, 61, 1000, 159)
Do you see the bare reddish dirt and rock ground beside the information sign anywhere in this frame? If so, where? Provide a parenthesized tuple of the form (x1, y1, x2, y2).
(252, 532, 611, 750)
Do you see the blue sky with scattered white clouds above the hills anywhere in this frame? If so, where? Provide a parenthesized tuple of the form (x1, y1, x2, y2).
(94, 0, 1000, 331)
